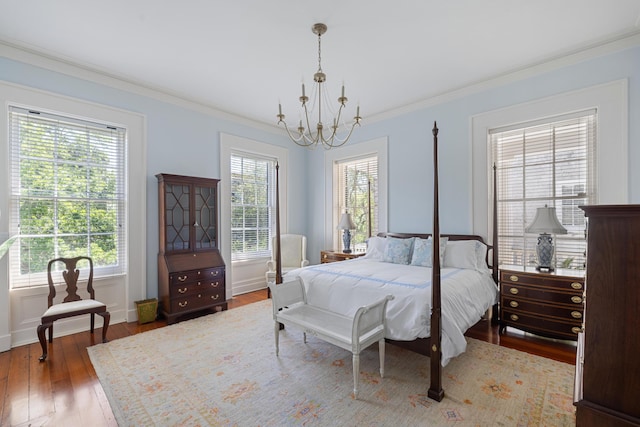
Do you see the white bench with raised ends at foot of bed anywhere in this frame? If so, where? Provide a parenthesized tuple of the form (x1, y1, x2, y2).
(269, 278, 393, 399)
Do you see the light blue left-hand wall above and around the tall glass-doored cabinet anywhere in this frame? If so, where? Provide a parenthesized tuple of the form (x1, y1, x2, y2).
(0, 56, 307, 298)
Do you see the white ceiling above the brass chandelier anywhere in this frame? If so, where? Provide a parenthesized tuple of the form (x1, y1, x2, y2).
(0, 0, 640, 125)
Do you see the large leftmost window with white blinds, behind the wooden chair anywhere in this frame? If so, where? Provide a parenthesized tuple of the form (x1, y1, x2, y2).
(9, 107, 127, 288)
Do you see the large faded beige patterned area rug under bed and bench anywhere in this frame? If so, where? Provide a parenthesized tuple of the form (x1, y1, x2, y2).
(88, 300, 575, 426)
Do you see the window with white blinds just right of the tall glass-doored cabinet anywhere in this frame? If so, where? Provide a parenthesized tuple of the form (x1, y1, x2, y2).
(231, 152, 276, 261)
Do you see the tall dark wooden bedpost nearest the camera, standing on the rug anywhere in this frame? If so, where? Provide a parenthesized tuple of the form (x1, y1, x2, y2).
(427, 122, 444, 402)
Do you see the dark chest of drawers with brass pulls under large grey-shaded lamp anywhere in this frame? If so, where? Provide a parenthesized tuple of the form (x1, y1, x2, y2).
(500, 266, 584, 340)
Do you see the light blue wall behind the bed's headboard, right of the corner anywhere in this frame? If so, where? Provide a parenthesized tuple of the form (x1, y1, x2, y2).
(308, 47, 640, 256)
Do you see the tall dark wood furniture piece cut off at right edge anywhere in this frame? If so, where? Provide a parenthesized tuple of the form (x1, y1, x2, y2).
(576, 205, 640, 427)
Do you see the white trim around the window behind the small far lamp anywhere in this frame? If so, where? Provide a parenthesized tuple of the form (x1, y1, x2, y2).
(323, 136, 389, 249)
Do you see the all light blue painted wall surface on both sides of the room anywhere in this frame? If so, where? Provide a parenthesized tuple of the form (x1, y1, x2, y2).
(0, 47, 640, 297)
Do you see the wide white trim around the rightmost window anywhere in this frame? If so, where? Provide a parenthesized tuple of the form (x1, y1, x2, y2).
(469, 79, 629, 243)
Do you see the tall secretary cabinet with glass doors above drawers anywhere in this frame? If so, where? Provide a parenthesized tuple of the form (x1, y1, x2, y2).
(156, 174, 227, 324)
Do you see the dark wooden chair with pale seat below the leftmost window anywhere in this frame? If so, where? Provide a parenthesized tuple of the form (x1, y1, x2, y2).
(38, 256, 111, 362)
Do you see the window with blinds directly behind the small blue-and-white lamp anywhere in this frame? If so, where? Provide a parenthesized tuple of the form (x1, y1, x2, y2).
(335, 156, 378, 252)
